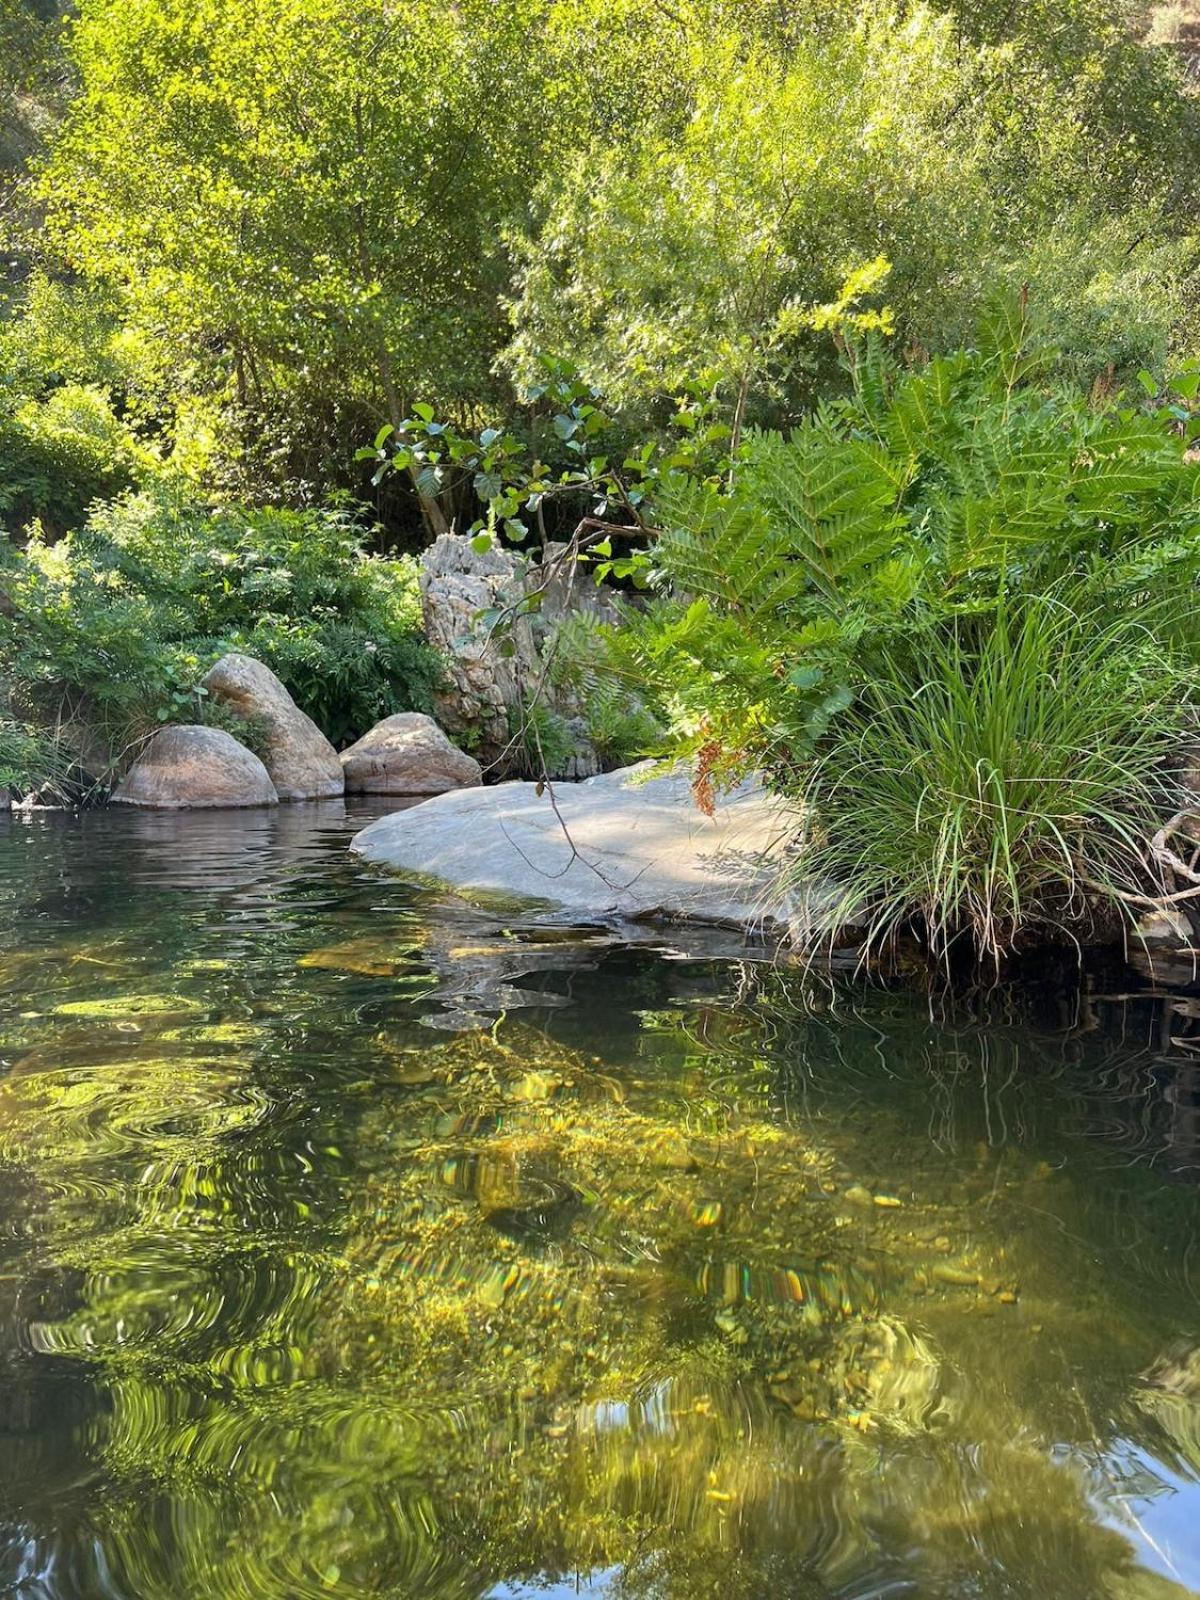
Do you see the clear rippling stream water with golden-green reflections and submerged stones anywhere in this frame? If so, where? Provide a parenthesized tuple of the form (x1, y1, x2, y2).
(0, 805, 1200, 1600)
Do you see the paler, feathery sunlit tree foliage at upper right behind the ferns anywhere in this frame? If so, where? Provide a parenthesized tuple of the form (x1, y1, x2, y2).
(507, 5, 1200, 421)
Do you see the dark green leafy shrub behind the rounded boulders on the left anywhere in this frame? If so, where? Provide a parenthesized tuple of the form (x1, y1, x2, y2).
(0, 490, 437, 754)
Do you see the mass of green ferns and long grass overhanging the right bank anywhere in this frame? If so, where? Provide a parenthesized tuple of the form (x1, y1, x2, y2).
(585, 301, 1200, 955)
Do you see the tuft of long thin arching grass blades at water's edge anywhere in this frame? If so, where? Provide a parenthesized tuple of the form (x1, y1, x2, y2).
(795, 595, 1192, 963)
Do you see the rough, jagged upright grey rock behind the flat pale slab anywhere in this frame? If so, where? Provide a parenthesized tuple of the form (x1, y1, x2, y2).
(421, 533, 616, 778)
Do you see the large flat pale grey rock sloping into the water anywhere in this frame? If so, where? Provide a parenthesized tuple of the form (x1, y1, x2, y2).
(350, 762, 819, 930)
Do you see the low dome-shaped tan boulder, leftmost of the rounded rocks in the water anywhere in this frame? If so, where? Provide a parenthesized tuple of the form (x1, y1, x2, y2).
(112, 723, 278, 810)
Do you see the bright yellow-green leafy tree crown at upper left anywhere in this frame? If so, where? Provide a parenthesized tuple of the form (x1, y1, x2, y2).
(42, 0, 556, 526)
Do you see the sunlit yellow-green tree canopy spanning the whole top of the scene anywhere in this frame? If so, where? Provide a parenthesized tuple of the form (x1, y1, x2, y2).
(5, 0, 1200, 524)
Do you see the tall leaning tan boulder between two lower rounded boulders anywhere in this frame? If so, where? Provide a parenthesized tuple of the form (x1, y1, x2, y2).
(203, 654, 342, 800)
